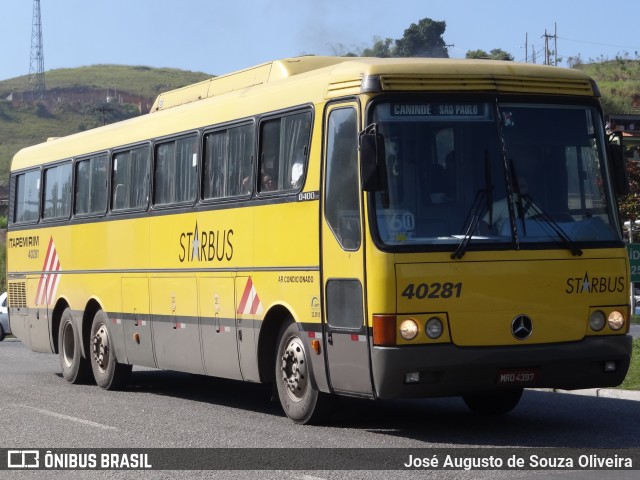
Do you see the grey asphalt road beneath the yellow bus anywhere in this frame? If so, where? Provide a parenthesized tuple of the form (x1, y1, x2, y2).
(0, 339, 640, 480)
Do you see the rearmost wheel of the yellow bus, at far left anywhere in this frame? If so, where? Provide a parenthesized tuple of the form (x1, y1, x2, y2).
(58, 307, 91, 384)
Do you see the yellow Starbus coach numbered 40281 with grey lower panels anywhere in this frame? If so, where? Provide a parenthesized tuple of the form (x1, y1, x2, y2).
(7, 57, 631, 423)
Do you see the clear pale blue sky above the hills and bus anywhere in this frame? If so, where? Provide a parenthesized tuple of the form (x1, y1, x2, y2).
(0, 0, 640, 80)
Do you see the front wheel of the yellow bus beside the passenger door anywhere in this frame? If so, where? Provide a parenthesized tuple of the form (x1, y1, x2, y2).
(275, 320, 329, 424)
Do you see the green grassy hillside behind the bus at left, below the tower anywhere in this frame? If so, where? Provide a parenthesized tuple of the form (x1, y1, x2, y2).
(0, 65, 212, 184)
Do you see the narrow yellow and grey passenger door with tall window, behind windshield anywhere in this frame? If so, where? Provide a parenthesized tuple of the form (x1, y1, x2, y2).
(321, 103, 373, 396)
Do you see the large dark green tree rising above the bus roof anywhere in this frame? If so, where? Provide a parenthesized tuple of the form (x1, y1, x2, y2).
(394, 18, 449, 58)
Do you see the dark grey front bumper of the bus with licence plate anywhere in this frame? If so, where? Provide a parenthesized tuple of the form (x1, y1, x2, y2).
(372, 335, 632, 398)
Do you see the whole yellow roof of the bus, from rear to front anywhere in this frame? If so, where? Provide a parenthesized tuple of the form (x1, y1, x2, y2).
(12, 56, 599, 170)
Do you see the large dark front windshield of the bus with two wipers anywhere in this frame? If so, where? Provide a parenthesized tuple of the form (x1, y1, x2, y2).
(373, 97, 619, 248)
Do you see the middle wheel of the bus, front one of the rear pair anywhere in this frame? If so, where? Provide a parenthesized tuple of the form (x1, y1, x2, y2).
(89, 310, 132, 390)
